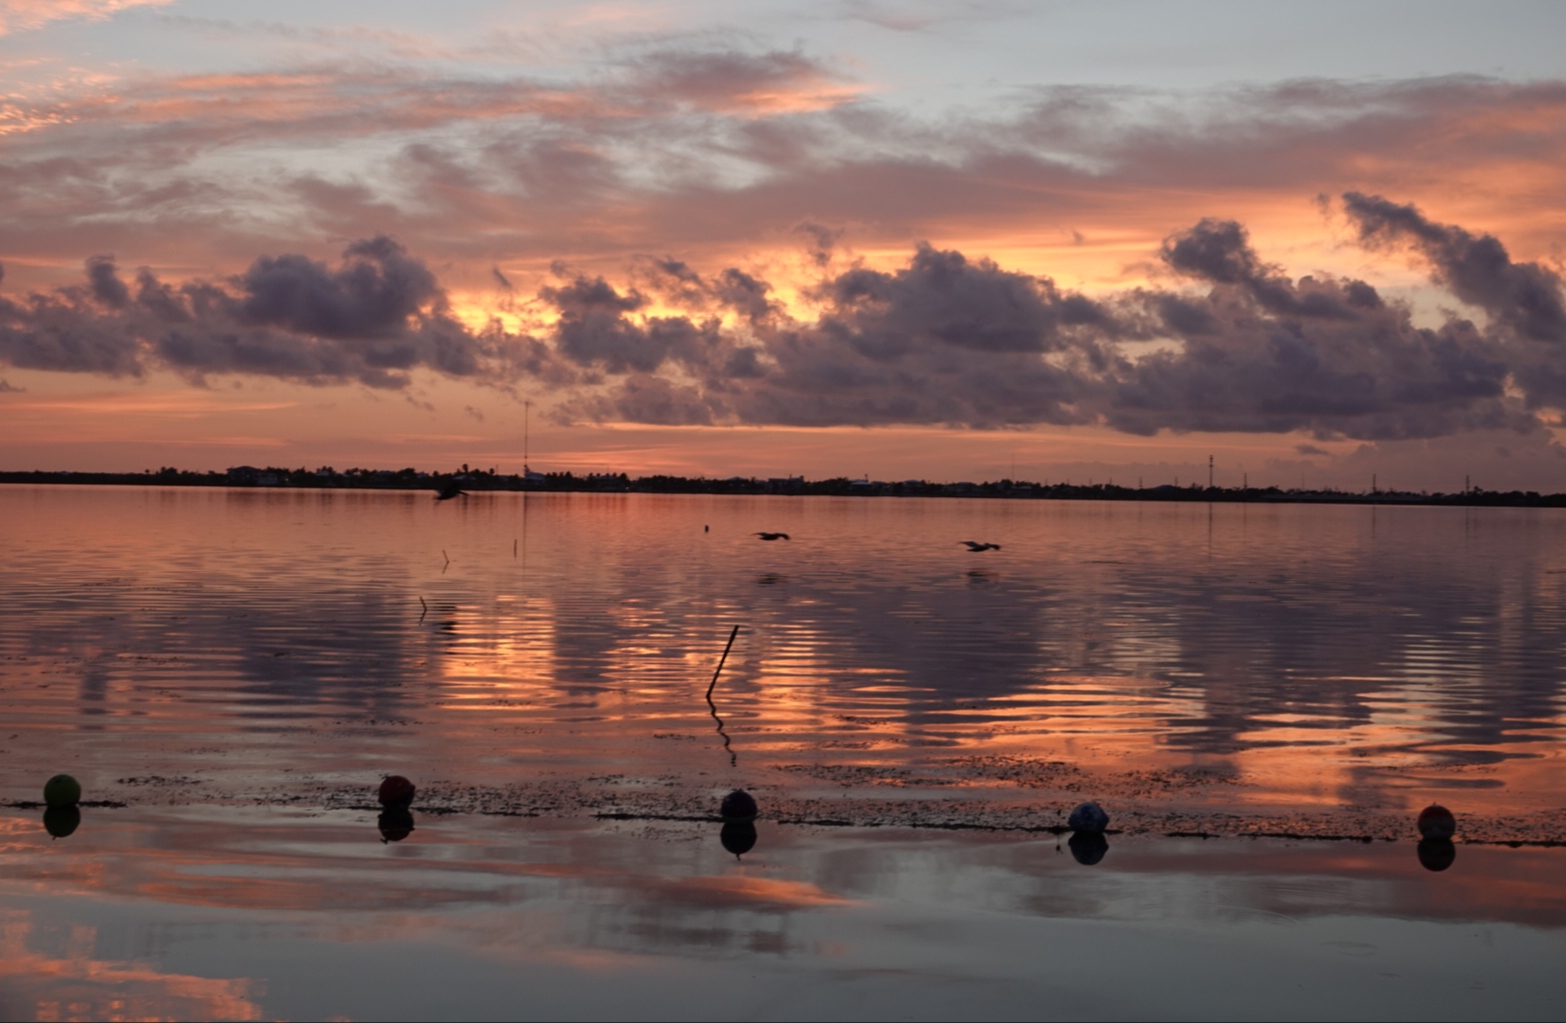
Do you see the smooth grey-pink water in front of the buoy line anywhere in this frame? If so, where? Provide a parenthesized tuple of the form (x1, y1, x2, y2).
(0, 807, 1566, 1020)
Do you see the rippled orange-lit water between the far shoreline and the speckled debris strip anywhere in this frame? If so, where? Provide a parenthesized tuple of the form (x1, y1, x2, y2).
(0, 487, 1566, 810)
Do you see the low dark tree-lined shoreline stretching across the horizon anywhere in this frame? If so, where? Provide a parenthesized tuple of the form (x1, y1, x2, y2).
(0, 465, 1566, 508)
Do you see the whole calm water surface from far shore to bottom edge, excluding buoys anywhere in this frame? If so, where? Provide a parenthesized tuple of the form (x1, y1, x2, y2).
(0, 487, 1566, 1018)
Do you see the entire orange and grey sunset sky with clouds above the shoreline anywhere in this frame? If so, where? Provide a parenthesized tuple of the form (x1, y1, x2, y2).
(0, 0, 1566, 490)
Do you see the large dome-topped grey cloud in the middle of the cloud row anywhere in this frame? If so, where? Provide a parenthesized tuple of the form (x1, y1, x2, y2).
(704, 246, 1117, 426)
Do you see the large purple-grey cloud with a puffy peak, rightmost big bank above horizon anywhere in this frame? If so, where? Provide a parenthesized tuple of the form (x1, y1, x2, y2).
(1104, 219, 1532, 439)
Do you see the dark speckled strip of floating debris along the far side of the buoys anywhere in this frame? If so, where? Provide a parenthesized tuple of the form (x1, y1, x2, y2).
(33, 757, 1566, 846)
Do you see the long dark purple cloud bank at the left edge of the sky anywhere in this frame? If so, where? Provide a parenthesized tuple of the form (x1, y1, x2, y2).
(0, 237, 553, 387)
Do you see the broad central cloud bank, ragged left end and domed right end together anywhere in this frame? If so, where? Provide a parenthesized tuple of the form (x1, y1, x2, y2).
(545, 239, 1120, 426)
